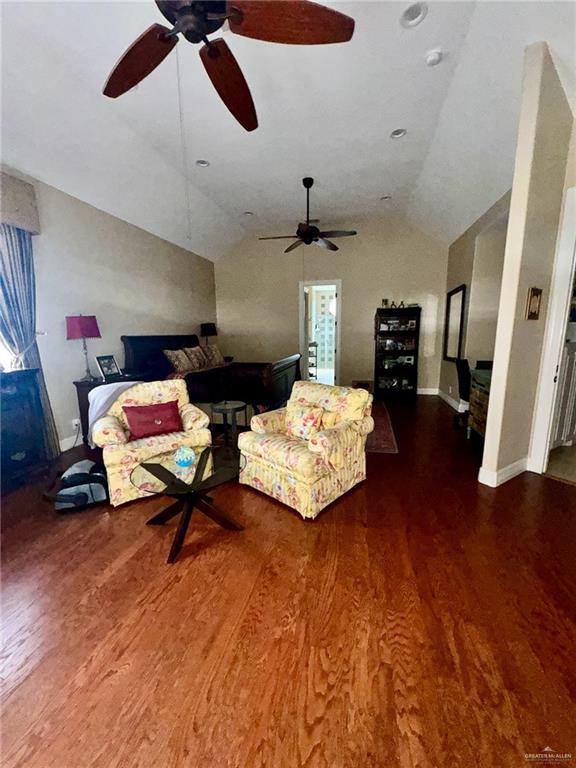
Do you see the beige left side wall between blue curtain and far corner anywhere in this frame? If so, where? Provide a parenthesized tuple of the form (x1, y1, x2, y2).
(28, 182, 216, 440)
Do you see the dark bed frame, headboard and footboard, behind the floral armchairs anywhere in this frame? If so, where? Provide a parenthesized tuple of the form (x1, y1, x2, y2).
(121, 334, 301, 411)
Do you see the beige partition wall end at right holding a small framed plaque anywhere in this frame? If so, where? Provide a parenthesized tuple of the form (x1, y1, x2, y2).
(480, 43, 573, 476)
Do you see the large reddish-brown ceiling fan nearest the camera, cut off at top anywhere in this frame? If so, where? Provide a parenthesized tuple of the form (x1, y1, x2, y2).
(104, 0, 354, 131)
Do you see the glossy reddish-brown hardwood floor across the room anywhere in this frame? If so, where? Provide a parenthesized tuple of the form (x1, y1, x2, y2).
(2, 397, 576, 768)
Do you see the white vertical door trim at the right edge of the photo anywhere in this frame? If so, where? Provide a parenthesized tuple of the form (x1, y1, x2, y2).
(528, 187, 576, 474)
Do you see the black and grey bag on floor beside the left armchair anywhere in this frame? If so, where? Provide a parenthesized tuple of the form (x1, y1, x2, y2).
(45, 459, 108, 514)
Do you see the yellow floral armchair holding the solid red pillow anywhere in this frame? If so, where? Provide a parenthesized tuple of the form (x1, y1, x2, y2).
(92, 379, 212, 507)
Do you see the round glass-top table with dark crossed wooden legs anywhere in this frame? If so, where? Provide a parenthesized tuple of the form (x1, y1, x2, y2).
(130, 446, 243, 563)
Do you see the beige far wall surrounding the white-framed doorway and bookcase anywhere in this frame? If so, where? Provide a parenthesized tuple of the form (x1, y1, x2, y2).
(216, 218, 447, 389)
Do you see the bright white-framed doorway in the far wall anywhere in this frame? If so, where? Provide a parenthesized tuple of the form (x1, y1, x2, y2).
(300, 280, 341, 384)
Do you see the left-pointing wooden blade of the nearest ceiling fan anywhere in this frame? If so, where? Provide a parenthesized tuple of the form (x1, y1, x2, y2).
(103, 24, 178, 99)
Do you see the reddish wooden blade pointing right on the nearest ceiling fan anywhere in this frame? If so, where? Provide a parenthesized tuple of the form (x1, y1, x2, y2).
(226, 0, 354, 45)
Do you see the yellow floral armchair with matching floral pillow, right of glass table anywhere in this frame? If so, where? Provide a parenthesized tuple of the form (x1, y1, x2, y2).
(238, 381, 374, 518)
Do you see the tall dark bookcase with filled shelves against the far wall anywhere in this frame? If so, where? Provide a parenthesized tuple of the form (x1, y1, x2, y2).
(374, 307, 421, 399)
